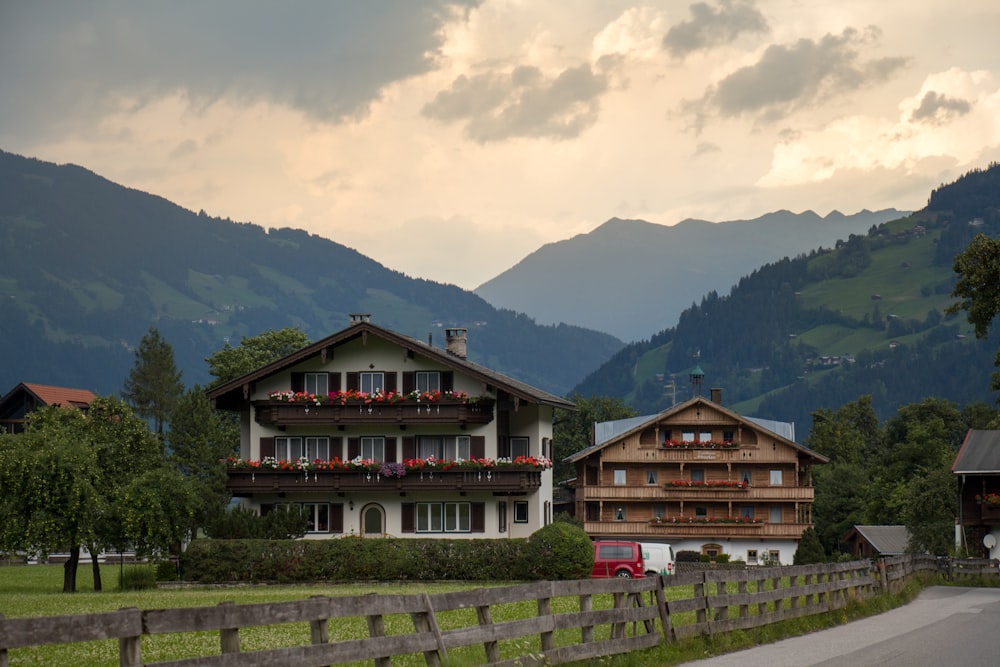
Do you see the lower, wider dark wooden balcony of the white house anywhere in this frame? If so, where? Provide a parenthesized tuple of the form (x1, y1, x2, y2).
(226, 466, 542, 496)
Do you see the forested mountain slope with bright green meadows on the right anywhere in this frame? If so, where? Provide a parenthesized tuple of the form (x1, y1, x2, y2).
(575, 164, 1000, 441)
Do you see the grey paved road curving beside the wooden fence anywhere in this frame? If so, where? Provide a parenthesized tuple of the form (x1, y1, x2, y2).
(685, 586, 1000, 667)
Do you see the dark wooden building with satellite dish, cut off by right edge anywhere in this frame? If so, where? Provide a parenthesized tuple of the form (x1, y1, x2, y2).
(951, 429, 1000, 558)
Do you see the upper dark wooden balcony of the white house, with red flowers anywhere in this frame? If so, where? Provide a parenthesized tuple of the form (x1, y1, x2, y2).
(253, 399, 494, 426)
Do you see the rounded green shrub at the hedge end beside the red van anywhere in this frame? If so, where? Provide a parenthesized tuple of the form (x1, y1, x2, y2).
(524, 521, 594, 580)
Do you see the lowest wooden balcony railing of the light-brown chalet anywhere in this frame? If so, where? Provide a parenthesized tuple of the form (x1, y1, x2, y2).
(583, 521, 812, 541)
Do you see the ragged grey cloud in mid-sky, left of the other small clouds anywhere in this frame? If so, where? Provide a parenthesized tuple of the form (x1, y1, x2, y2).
(423, 64, 609, 144)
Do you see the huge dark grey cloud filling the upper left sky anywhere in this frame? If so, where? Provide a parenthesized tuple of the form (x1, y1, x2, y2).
(0, 0, 475, 144)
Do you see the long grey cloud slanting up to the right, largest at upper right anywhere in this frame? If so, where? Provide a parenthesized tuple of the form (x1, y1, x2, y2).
(692, 28, 908, 121)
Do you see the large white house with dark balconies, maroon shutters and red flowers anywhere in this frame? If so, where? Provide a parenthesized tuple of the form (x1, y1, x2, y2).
(208, 314, 575, 538)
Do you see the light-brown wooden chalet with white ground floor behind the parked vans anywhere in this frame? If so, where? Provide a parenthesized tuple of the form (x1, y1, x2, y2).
(567, 389, 829, 565)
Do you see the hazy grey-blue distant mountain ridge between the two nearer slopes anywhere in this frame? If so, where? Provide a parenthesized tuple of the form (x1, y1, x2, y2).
(474, 209, 906, 341)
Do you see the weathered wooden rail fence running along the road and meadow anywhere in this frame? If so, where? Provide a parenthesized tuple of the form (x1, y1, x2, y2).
(0, 556, 984, 667)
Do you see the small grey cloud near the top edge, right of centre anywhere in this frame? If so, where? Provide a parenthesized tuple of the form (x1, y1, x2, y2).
(663, 0, 768, 58)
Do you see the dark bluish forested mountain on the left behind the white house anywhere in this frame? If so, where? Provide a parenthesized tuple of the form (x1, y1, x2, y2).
(0, 151, 622, 395)
